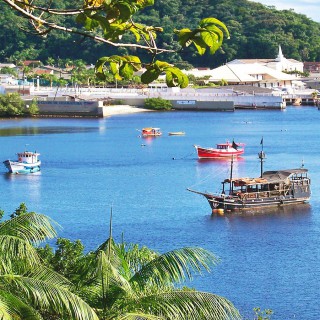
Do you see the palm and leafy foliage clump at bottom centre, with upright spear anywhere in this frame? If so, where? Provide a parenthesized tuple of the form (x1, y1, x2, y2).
(39, 215, 240, 320)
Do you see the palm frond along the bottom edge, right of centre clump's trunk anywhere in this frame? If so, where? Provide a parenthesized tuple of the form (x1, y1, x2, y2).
(130, 290, 241, 320)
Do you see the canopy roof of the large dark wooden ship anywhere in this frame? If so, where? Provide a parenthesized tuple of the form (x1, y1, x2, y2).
(224, 168, 308, 186)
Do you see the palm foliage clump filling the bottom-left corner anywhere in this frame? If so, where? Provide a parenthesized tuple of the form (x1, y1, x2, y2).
(0, 204, 98, 320)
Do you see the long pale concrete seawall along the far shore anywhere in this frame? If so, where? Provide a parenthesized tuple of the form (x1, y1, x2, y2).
(25, 88, 286, 117)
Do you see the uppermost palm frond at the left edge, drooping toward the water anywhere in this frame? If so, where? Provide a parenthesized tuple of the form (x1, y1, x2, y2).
(0, 212, 59, 244)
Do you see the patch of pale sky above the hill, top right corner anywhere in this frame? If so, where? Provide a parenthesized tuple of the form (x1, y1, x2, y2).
(250, 0, 320, 22)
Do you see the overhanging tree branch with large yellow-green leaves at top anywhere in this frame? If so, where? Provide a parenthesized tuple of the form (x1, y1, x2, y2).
(2, 0, 229, 88)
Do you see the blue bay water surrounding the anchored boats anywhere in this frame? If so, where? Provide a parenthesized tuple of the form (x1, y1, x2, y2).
(0, 107, 320, 320)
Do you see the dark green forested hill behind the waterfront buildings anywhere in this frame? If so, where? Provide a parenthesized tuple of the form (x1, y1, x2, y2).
(0, 0, 320, 67)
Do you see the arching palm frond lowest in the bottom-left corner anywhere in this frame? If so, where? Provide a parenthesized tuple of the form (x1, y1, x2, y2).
(1, 275, 98, 320)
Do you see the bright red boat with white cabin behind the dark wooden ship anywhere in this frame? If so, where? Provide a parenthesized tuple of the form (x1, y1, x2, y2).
(194, 141, 244, 159)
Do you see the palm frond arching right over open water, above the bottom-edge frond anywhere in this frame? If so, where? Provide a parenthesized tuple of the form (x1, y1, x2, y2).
(130, 247, 219, 288)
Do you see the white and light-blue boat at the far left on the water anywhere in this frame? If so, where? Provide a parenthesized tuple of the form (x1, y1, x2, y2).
(3, 151, 41, 174)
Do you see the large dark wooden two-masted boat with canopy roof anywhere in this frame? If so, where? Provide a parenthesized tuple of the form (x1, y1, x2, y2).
(188, 152, 311, 213)
